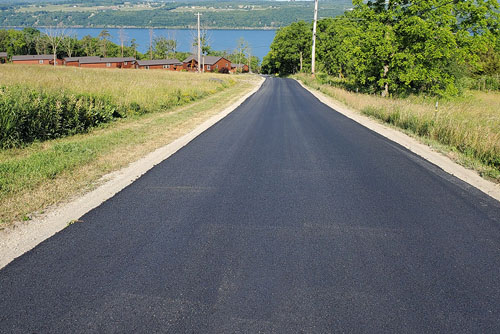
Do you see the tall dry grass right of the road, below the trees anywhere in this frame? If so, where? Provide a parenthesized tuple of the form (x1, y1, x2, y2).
(295, 74, 500, 182)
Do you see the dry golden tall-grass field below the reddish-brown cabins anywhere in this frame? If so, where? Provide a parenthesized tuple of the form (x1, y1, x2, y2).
(0, 64, 234, 111)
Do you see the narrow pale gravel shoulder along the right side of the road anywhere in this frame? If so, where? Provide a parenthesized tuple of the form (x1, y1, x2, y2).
(294, 79, 500, 202)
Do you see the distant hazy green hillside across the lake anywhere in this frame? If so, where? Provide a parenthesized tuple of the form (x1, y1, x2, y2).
(0, 0, 352, 29)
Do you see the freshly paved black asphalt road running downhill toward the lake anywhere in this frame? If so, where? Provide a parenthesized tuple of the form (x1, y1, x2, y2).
(0, 78, 500, 333)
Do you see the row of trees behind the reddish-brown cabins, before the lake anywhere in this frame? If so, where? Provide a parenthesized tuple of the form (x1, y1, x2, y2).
(0, 28, 259, 72)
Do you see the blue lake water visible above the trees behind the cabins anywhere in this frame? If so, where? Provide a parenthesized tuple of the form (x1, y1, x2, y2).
(68, 28, 276, 61)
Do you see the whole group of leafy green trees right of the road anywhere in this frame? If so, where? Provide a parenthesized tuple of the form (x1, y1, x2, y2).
(262, 0, 500, 96)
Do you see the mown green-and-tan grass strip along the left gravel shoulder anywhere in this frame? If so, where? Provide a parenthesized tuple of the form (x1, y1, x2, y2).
(0, 71, 258, 228)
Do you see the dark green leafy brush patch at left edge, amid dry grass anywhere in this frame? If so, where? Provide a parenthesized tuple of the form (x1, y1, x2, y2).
(0, 85, 120, 148)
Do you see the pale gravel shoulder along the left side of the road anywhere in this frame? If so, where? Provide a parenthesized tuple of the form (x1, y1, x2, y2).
(0, 77, 265, 269)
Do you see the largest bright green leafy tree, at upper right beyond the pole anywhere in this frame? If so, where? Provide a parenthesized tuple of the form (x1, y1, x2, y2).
(346, 0, 499, 95)
